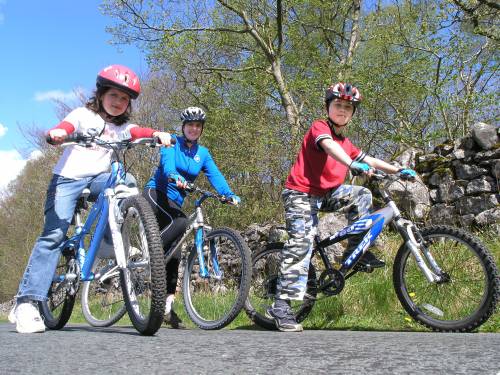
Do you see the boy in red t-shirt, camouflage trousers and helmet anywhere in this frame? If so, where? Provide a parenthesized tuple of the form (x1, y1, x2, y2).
(266, 83, 415, 331)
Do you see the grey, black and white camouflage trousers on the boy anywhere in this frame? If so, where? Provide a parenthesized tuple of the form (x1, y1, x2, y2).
(276, 185, 372, 300)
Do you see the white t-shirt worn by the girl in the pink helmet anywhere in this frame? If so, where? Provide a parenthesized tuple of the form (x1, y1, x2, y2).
(53, 107, 137, 180)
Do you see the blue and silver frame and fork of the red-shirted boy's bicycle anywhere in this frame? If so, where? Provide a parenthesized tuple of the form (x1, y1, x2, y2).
(315, 175, 443, 282)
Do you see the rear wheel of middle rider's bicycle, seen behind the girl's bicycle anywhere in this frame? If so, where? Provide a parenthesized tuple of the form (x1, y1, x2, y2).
(82, 258, 127, 327)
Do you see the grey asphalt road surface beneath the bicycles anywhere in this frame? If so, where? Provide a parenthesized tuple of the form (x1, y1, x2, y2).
(0, 323, 500, 375)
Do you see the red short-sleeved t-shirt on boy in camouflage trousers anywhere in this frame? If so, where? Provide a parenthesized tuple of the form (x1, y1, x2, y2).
(285, 120, 361, 196)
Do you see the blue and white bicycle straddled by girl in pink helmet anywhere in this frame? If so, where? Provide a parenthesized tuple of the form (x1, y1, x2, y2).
(39, 134, 166, 335)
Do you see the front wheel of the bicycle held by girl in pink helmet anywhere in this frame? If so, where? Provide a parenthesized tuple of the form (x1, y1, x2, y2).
(120, 195, 166, 336)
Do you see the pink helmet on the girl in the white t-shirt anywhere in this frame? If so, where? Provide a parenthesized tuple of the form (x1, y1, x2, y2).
(96, 65, 141, 99)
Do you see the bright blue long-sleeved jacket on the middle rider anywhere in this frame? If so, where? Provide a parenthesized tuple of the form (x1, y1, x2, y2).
(146, 135, 234, 207)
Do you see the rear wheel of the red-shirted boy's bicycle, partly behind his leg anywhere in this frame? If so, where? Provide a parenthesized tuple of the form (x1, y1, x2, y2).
(244, 242, 317, 330)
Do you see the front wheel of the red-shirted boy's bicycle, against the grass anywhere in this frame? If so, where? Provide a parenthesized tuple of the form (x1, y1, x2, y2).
(393, 225, 500, 332)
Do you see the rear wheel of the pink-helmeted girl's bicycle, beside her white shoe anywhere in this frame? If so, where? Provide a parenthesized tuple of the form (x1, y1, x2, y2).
(38, 253, 76, 330)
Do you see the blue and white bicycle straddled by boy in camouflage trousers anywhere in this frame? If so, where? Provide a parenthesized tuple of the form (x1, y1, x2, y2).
(245, 171, 500, 332)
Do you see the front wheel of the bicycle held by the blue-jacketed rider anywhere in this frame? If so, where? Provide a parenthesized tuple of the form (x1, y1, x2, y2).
(183, 228, 252, 330)
